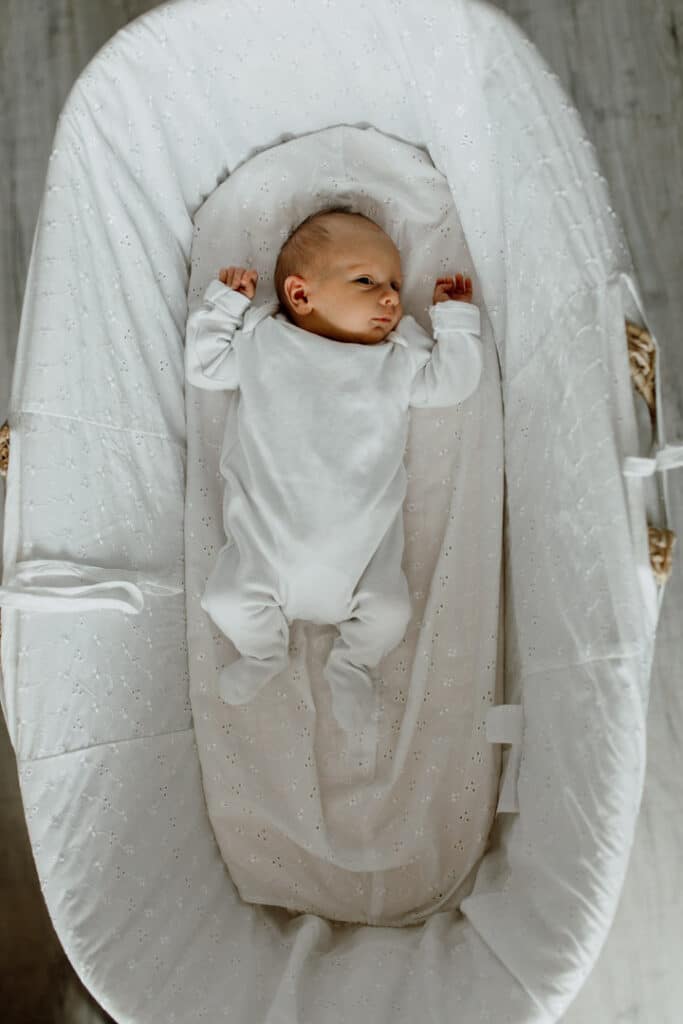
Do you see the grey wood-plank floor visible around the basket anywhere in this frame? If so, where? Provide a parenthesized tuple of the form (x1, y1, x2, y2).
(0, 0, 683, 1024)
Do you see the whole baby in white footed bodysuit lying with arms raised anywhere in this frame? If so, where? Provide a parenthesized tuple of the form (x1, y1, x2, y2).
(185, 207, 482, 730)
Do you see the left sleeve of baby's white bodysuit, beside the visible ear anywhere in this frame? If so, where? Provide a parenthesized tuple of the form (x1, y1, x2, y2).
(185, 279, 251, 391)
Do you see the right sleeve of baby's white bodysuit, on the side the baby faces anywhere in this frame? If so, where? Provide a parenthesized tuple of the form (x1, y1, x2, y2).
(410, 299, 483, 409)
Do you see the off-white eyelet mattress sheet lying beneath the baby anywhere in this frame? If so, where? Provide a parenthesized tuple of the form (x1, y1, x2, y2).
(185, 126, 503, 926)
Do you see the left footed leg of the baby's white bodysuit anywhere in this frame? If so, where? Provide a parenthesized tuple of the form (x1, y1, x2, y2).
(201, 544, 290, 705)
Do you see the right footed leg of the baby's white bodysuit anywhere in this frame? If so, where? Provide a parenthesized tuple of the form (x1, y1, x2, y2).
(323, 509, 412, 731)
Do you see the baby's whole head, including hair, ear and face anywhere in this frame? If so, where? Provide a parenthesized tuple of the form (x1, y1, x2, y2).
(274, 207, 403, 345)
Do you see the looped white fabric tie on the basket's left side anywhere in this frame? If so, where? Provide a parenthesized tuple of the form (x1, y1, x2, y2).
(0, 559, 183, 615)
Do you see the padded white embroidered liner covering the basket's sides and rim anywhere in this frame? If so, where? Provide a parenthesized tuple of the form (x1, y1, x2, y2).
(1, 0, 675, 1024)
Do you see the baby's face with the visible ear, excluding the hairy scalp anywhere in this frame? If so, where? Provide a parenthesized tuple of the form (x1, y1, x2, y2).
(286, 223, 403, 345)
